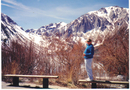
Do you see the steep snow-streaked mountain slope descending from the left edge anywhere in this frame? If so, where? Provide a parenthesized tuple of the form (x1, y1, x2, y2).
(1, 13, 46, 45)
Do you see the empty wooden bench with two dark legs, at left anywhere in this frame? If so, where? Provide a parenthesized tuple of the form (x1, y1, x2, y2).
(4, 74, 58, 88)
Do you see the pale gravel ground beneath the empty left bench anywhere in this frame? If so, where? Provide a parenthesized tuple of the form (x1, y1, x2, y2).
(1, 81, 69, 89)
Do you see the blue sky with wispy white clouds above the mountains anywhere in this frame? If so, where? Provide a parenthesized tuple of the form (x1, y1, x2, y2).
(1, 0, 129, 30)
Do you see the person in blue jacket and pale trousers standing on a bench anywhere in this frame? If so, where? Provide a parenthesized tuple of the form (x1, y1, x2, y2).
(83, 39, 94, 81)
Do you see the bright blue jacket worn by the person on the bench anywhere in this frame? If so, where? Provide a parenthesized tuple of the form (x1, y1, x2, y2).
(84, 44, 94, 59)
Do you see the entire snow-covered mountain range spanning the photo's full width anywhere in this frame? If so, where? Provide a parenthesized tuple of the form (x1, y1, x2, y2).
(1, 6, 129, 45)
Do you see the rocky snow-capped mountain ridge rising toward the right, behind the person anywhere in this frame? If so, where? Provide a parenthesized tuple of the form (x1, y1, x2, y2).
(26, 6, 129, 44)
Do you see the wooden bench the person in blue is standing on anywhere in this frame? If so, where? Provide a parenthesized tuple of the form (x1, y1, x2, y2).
(79, 80, 129, 88)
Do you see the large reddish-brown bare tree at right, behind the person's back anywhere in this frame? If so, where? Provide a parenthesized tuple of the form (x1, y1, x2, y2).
(95, 24, 129, 79)
